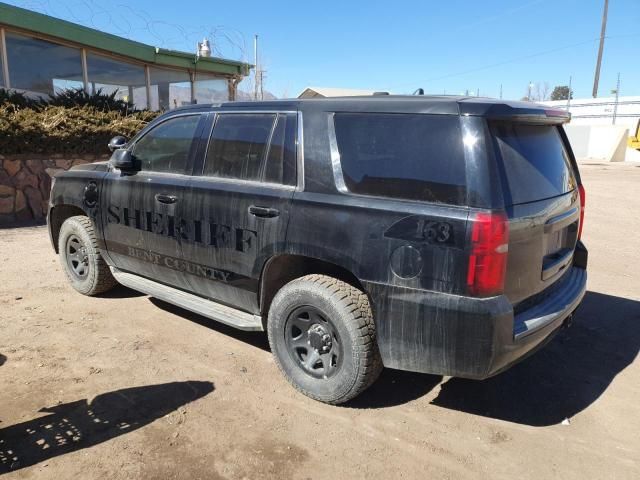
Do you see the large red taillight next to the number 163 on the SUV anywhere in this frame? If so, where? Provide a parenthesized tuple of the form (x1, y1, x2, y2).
(467, 212, 509, 297)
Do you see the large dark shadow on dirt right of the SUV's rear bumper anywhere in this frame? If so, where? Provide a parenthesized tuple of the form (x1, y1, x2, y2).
(433, 292, 640, 426)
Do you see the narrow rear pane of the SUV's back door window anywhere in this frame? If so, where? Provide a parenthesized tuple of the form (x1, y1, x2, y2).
(264, 114, 296, 185)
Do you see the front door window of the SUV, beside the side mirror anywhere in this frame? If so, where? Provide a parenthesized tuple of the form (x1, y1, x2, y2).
(132, 115, 200, 173)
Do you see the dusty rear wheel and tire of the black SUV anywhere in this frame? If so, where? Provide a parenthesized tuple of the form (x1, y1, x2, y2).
(267, 275, 382, 405)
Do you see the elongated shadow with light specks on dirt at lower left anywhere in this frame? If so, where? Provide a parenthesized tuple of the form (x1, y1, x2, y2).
(0, 381, 214, 475)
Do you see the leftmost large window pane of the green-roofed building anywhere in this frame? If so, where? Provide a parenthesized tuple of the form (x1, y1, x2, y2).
(5, 32, 84, 95)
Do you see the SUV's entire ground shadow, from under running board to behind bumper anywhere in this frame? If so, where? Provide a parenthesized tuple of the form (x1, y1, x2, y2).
(107, 286, 640, 418)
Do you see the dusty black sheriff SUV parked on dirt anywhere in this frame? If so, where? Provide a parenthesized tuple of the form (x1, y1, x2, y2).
(48, 96, 587, 404)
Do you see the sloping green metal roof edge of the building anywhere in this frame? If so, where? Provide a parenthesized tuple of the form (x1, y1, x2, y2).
(0, 2, 252, 75)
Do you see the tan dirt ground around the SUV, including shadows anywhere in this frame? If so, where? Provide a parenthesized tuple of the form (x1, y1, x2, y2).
(0, 165, 640, 480)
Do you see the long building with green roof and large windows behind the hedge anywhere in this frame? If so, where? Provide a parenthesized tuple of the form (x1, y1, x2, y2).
(0, 3, 252, 110)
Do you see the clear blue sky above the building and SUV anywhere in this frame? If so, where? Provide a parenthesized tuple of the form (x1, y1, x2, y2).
(7, 0, 640, 98)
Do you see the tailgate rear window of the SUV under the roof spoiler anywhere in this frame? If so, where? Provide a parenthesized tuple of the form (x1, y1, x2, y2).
(491, 123, 576, 205)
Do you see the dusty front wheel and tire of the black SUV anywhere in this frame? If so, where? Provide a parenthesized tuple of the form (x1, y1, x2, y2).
(58, 216, 117, 296)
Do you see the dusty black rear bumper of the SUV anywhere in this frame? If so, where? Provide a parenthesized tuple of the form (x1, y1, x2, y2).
(365, 266, 587, 379)
